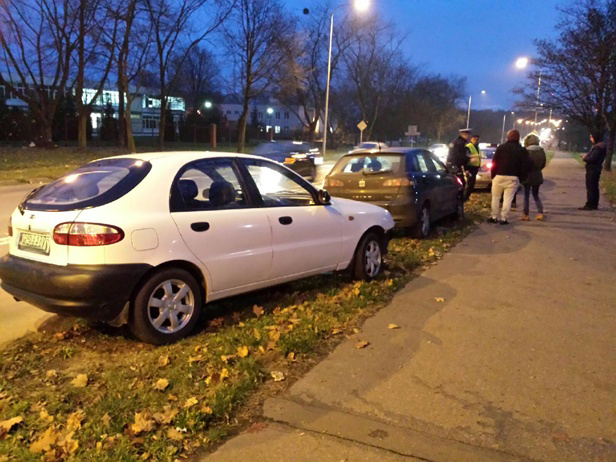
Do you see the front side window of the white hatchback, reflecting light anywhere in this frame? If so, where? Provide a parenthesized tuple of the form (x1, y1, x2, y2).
(243, 159, 316, 207)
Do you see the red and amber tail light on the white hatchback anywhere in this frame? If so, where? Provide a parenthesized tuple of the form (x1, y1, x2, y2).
(53, 223, 124, 247)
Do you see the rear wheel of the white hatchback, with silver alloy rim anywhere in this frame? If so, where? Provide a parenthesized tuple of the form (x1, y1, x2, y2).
(129, 268, 202, 345)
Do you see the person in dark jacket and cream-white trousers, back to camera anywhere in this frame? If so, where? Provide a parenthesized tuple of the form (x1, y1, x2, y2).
(488, 130, 530, 225)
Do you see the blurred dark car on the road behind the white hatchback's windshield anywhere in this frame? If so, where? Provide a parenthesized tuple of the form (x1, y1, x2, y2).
(252, 141, 323, 181)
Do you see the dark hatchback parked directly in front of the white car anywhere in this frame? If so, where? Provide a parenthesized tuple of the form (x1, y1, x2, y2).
(323, 148, 464, 238)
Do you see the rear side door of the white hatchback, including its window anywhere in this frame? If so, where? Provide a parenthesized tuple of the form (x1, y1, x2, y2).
(171, 158, 273, 292)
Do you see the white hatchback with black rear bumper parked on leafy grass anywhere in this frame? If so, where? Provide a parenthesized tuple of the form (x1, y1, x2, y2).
(0, 152, 394, 344)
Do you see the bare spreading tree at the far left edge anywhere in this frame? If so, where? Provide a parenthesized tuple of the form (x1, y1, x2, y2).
(0, 0, 78, 147)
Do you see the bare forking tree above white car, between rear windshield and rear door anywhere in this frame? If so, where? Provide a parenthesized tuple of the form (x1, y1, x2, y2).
(144, 0, 233, 149)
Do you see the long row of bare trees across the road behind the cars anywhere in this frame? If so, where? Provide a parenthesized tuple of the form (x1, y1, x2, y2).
(0, 0, 465, 151)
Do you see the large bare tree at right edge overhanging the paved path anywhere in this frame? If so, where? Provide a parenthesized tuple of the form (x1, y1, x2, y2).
(517, 0, 616, 170)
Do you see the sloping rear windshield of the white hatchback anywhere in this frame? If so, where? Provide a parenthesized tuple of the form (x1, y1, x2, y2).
(21, 158, 152, 211)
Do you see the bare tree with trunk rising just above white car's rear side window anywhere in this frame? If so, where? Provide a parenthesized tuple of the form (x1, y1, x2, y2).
(224, 0, 295, 152)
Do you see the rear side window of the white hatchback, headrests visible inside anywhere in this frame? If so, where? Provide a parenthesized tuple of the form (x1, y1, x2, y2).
(171, 158, 249, 212)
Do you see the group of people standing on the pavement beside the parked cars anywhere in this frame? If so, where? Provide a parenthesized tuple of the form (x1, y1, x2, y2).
(447, 128, 607, 225)
